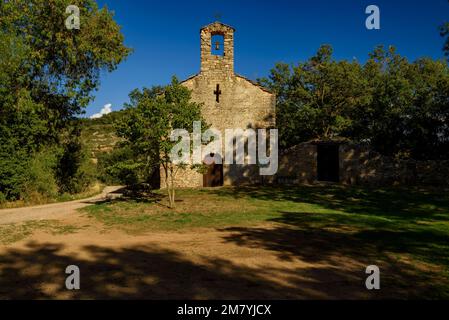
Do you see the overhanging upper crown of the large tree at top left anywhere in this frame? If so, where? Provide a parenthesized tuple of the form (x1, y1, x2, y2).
(0, 0, 130, 124)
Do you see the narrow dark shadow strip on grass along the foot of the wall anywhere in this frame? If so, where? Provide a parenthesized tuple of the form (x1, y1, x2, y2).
(208, 185, 449, 221)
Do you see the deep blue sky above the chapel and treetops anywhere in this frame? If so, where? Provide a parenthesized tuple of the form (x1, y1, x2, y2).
(86, 0, 449, 116)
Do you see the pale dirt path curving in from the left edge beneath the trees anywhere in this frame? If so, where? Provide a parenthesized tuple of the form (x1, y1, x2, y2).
(0, 186, 122, 224)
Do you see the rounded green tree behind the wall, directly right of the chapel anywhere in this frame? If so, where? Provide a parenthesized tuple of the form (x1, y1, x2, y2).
(259, 45, 370, 148)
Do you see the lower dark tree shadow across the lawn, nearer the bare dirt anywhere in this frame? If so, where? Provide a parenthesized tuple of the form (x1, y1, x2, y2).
(221, 212, 449, 270)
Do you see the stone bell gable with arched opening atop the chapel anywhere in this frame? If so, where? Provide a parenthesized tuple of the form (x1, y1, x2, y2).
(200, 22, 235, 77)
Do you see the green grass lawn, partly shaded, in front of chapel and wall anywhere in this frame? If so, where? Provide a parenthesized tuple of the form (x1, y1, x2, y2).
(84, 186, 449, 297)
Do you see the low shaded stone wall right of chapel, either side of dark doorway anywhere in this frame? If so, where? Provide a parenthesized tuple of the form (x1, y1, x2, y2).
(270, 141, 449, 186)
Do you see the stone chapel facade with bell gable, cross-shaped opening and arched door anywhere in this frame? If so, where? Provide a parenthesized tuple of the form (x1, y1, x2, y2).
(161, 22, 276, 188)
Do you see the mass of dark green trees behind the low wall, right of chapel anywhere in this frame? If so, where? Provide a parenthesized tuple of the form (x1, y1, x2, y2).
(259, 46, 449, 159)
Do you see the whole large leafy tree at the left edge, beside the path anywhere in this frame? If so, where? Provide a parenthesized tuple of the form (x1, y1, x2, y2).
(0, 0, 131, 199)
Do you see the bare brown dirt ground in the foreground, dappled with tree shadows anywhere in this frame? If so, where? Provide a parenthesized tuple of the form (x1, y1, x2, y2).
(0, 226, 376, 299)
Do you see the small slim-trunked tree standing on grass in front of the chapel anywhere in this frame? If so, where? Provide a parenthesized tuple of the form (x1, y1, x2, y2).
(115, 77, 207, 207)
